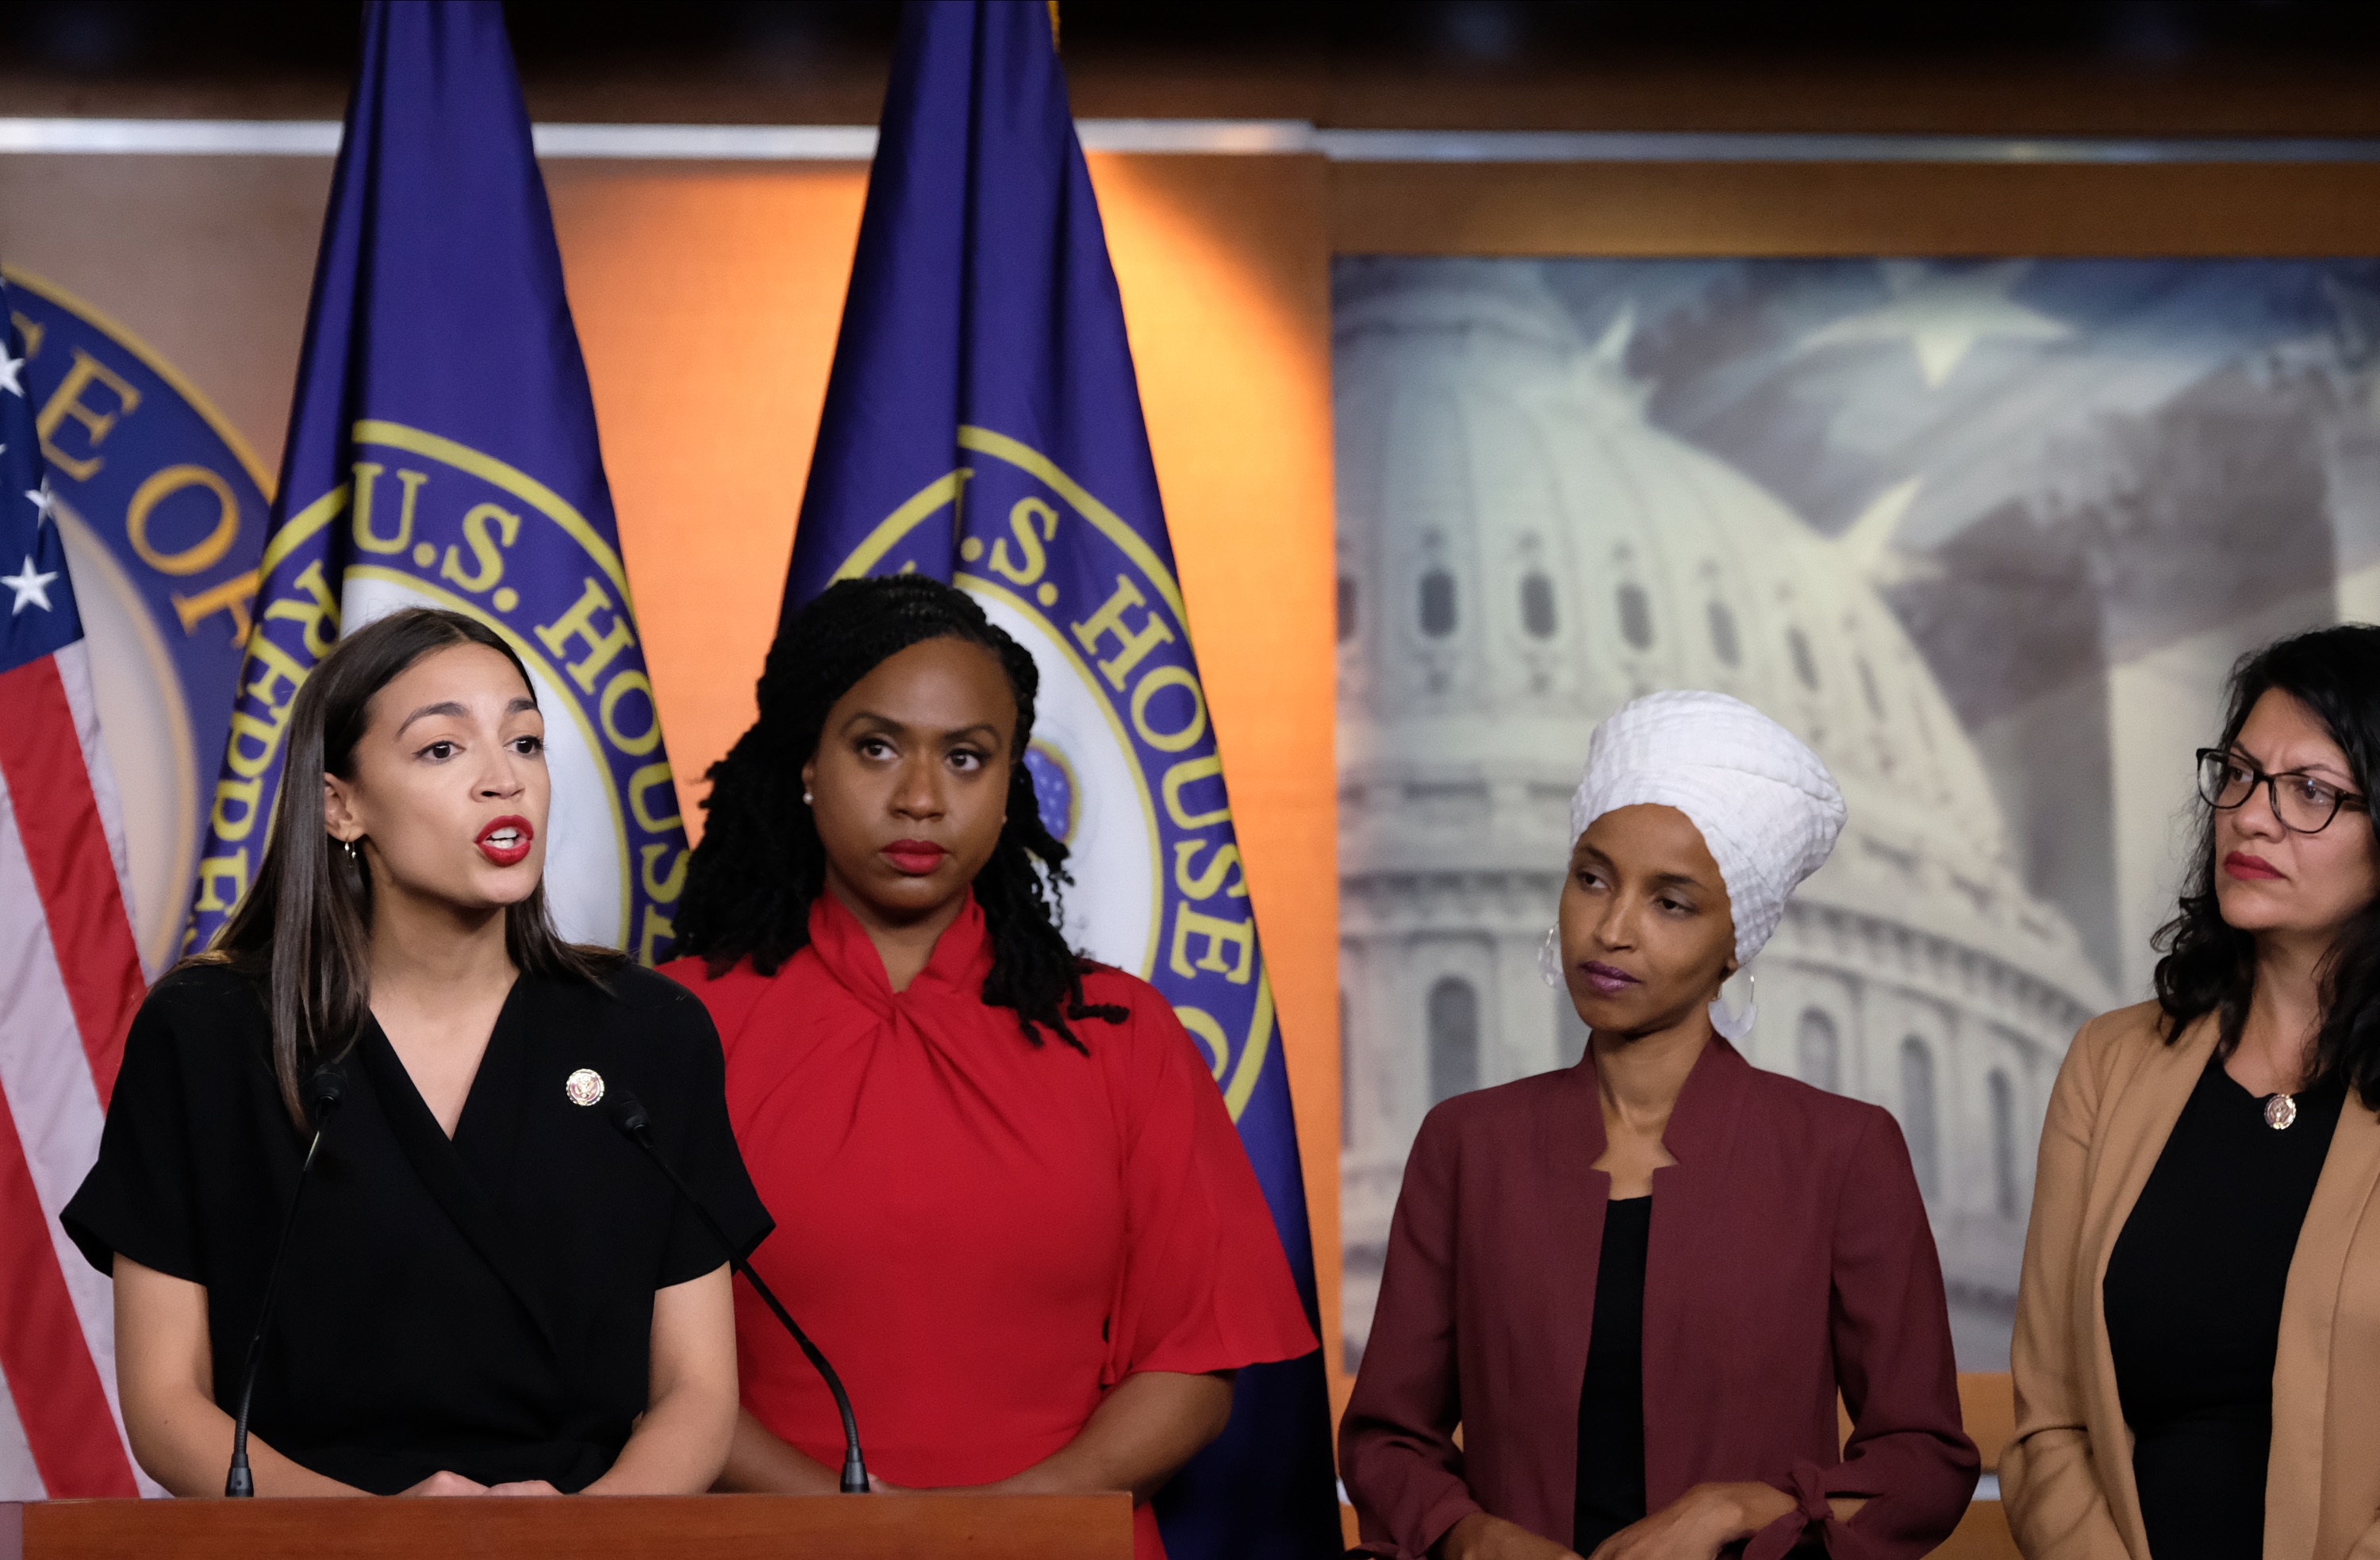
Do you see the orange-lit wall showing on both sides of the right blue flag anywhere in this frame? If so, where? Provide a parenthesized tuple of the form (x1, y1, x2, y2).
(545, 157, 1340, 1377)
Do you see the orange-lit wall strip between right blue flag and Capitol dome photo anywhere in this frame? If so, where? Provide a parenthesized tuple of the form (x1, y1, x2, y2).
(1090, 157, 1342, 1403)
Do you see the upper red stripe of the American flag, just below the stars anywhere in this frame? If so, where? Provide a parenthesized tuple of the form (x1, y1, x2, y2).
(0, 655, 148, 1105)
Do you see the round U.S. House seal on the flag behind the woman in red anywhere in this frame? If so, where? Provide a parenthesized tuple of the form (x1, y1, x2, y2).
(835, 426, 1273, 1120)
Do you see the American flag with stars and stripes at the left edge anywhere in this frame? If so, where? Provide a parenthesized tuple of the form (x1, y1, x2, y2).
(0, 275, 148, 1500)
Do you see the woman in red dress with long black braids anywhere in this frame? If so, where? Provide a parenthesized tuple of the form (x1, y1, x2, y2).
(669, 576, 1316, 1558)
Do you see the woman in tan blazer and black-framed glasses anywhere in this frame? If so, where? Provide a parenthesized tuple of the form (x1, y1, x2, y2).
(1999, 626, 2380, 1560)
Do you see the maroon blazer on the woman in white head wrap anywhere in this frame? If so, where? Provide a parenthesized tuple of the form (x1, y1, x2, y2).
(1340, 1039, 1978, 1560)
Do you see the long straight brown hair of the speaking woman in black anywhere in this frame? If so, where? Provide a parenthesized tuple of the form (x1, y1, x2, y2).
(193, 607, 621, 1132)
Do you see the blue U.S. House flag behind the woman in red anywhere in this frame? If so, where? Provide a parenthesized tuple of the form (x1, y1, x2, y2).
(785, 0, 1340, 1560)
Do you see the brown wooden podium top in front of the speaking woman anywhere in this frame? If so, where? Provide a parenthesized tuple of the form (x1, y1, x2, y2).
(0, 1496, 1133, 1560)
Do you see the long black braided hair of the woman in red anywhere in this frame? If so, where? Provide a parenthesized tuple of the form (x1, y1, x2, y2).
(676, 574, 1130, 1055)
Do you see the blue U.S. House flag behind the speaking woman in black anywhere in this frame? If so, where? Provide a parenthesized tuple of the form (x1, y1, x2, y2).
(188, 0, 685, 963)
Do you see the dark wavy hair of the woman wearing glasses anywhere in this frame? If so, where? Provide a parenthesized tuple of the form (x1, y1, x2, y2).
(2156, 624, 2380, 1110)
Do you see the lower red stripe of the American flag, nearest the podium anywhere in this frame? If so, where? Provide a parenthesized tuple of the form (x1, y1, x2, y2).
(0, 1085, 140, 1498)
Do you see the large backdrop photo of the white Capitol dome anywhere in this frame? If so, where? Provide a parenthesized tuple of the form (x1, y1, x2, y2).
(1335, 257, 2380, 1370)
